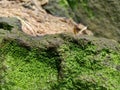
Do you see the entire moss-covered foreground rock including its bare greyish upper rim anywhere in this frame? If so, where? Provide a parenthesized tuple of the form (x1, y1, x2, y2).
(0, 18, 120, 90)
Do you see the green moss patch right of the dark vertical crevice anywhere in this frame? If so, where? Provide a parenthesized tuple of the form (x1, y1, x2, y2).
(54, 44, 120, 90)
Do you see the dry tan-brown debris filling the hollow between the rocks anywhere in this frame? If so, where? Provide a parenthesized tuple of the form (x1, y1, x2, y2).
(0, 0, 93, 36)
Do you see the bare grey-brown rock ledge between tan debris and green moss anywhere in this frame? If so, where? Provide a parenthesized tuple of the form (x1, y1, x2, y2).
(0, 17, 119, 50)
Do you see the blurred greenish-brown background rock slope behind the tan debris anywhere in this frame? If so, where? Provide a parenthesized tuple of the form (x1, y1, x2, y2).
(44, 0, 120, 41)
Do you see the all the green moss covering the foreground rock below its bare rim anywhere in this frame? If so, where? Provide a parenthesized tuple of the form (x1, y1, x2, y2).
(0, 37, 120, 90)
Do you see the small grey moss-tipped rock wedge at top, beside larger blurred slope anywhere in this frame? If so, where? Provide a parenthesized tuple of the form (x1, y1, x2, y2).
(43, 0, 75, 18)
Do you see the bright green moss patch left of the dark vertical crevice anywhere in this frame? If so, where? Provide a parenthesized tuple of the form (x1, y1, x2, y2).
(1, 42, 57, 90)
